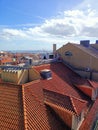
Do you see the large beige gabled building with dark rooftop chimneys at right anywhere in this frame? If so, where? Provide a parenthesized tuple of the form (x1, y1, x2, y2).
(57, 41, 98, 81)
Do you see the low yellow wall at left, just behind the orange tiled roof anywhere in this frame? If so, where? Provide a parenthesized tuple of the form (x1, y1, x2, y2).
(1, 68, 40, 84)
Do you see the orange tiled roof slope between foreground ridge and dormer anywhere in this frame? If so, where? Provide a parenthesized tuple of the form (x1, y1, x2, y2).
(22, 82, 67, 130)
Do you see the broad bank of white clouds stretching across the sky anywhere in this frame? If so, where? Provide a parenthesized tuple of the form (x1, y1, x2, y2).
(0, 0, 98, 43)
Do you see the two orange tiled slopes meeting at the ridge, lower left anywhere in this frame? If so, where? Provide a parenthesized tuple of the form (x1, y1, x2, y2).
(0, 81, 68, 130)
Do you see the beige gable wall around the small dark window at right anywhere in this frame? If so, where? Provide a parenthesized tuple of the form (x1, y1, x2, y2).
(57, 43, 98, 71)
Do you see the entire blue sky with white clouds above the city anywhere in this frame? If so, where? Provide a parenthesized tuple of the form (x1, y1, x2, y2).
(0, 0, 98, 50)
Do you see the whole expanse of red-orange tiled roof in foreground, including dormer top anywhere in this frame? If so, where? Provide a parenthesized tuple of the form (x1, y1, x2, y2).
(0, 63, 98, 130)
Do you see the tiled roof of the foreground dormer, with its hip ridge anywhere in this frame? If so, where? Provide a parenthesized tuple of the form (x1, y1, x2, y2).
(43, 89, 87, 115)
